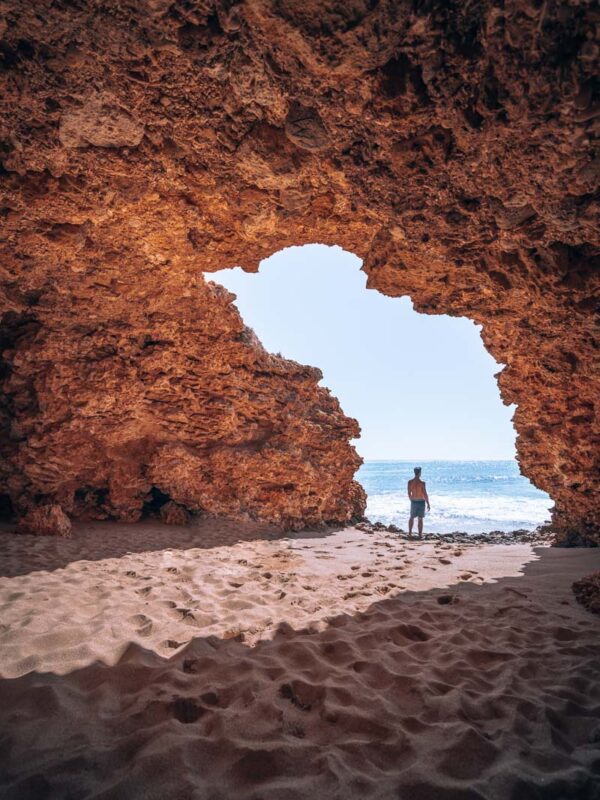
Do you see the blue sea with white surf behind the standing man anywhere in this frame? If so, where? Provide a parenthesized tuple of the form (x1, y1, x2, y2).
(356, 461, 553, 533)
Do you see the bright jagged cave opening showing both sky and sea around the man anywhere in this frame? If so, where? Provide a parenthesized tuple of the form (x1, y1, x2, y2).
(211, 244, 552, 533)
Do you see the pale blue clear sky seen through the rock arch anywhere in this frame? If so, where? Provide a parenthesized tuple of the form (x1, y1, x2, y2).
(206, 244, 515, 461)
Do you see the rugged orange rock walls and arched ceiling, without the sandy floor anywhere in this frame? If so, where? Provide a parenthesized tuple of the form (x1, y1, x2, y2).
(0, 0, 600, 540)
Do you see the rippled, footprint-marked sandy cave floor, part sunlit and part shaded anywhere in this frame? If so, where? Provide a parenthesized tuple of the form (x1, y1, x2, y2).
(0, 520, 600, 800)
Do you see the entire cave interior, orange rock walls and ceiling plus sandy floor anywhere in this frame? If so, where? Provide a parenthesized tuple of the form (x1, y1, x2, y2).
(0, 0, 600, 800)
